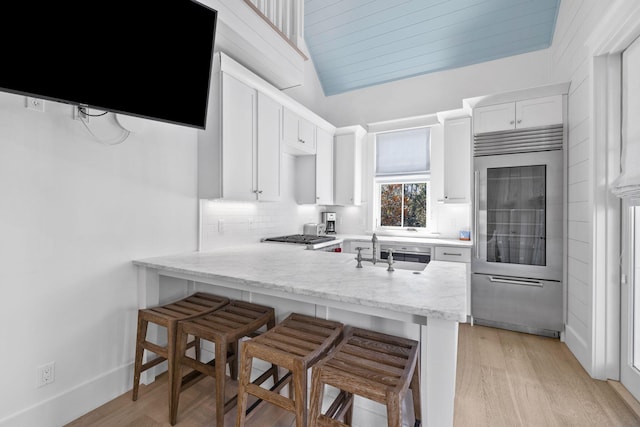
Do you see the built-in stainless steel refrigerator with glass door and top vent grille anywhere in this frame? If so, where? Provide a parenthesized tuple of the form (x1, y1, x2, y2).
(471, 128, 564, 336)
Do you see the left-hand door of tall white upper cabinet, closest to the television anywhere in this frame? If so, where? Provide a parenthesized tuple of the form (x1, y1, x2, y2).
(222, 74, 257, 200)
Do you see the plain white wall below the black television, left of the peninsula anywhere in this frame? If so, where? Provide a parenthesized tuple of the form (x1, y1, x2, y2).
(0, 93, 198, 427)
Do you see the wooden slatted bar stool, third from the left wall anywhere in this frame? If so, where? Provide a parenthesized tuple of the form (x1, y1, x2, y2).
(236, 313, 343, 427)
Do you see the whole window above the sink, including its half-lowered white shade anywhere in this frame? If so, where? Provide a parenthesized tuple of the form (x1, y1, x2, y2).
(375, 127, 430, 229)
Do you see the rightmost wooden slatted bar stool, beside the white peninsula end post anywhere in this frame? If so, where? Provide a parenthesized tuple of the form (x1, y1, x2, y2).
(309, 328, 421, 427)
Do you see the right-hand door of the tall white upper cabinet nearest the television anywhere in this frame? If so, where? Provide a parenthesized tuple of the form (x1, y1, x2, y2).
(257, 92, 282, 202)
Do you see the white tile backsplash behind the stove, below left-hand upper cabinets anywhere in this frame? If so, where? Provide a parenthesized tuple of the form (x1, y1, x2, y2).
(200, 154, 321, 251)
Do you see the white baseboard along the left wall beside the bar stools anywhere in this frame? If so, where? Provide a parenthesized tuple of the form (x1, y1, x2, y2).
(0, 364, 133, 427)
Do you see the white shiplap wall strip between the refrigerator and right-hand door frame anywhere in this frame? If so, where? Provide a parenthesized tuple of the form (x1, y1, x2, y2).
(552, 0, 619, 375)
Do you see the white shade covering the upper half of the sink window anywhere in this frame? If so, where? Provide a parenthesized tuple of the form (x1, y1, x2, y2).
(376, 128, 431, 177)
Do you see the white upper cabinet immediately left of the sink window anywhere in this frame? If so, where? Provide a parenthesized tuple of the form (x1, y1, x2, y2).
(333, 126, 366, 206)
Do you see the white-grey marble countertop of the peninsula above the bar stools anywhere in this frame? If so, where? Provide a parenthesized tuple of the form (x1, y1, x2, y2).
(133, 244, 468, 321)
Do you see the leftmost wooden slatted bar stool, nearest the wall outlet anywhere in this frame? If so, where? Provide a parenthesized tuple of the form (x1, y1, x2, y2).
(132, 292, 229, 401)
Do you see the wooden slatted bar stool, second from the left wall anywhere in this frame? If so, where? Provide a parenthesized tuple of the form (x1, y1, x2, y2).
(169, 300, 278, 427)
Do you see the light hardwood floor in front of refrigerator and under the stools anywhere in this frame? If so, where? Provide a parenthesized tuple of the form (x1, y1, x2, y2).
(68, 324, 640, 427)
